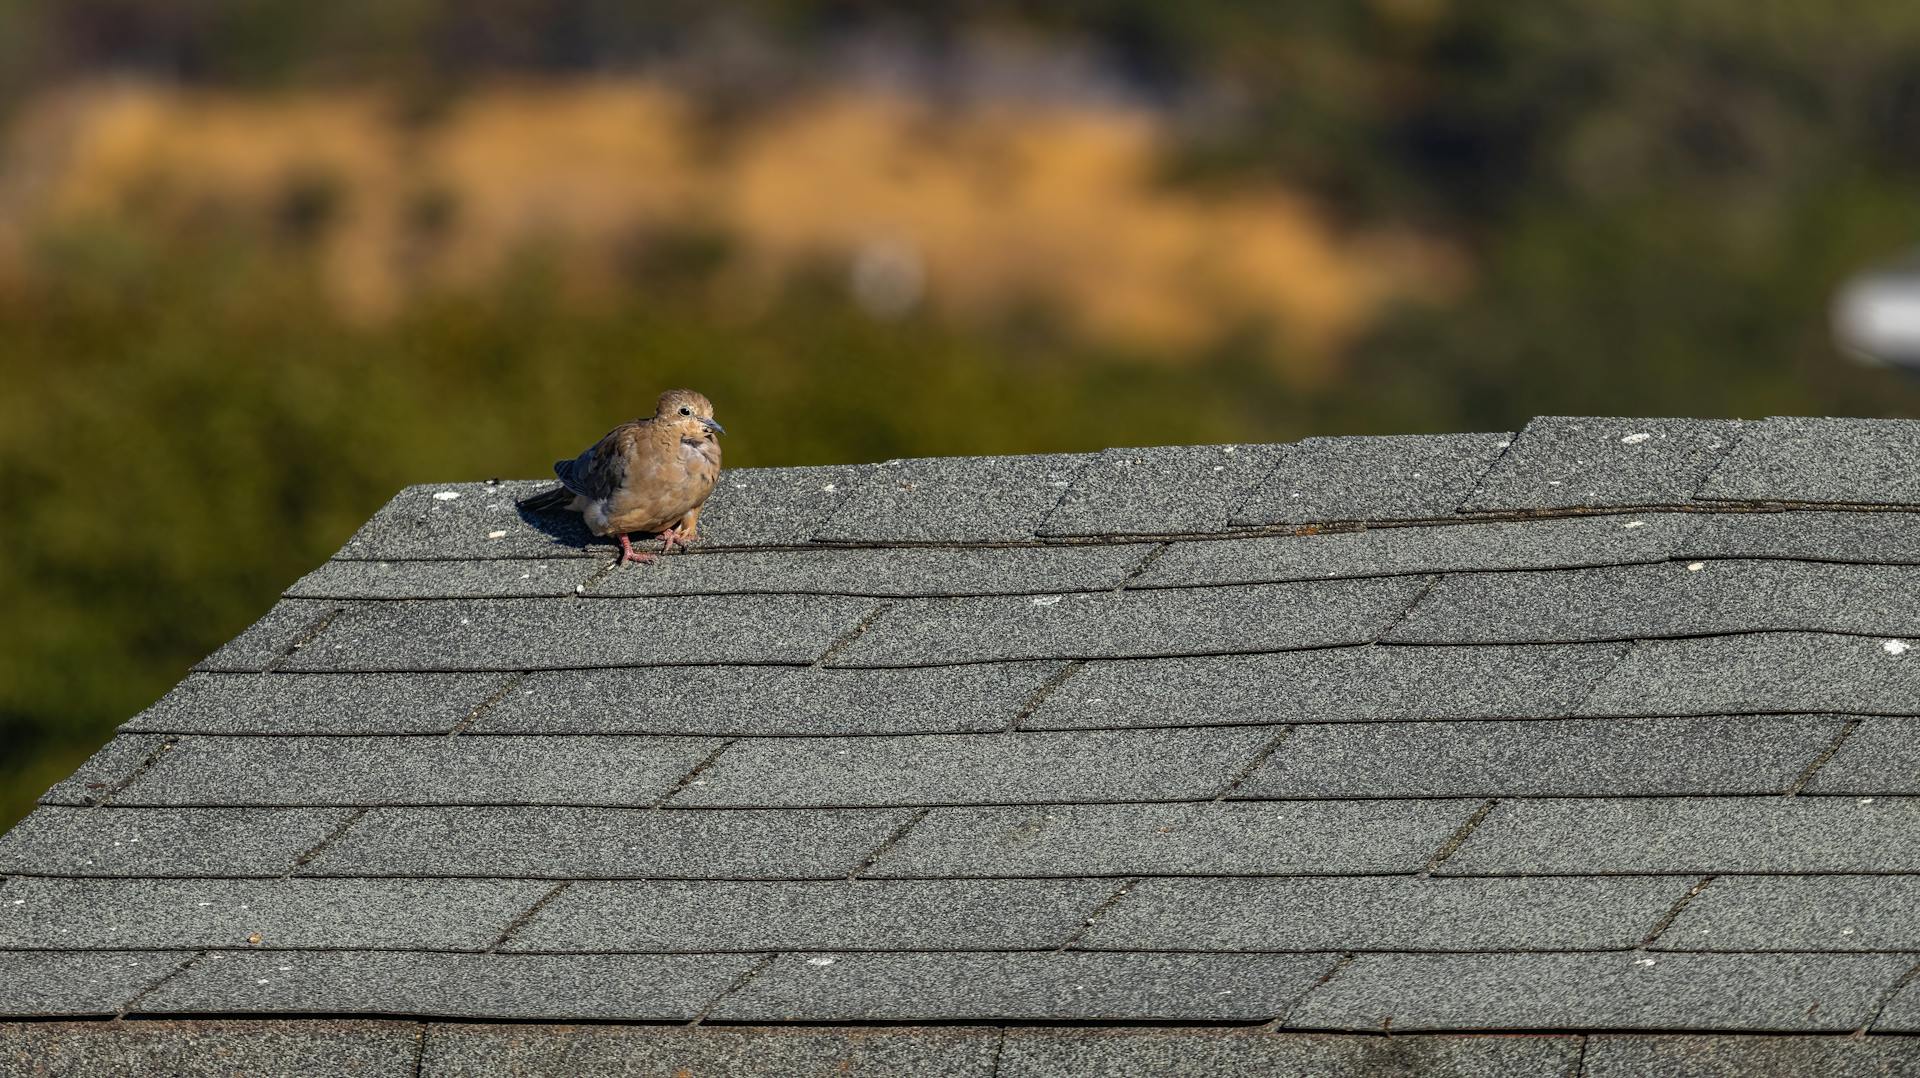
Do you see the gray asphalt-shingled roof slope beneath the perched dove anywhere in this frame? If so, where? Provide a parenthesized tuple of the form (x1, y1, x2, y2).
(0, 409, 1920, 1074)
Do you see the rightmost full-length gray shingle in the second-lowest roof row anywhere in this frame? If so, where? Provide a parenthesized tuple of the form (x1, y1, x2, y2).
(1288, 951, 1910, 1032)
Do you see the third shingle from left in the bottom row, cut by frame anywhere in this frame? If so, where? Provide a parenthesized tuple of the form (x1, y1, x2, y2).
(998, 1028, 1580, 1078)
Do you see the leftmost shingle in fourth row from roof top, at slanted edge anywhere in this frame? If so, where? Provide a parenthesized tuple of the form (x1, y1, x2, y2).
(121, 673, 507, 734)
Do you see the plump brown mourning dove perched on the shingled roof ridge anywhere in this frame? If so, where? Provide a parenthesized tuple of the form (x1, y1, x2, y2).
(520, 390, 726, 563)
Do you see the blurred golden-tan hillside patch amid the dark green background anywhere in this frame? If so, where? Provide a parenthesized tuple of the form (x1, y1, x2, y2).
(0, 79, 1461, 377)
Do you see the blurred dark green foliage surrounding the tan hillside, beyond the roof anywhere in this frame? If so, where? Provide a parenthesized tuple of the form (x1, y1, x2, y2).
(0, 0, 1920, 822)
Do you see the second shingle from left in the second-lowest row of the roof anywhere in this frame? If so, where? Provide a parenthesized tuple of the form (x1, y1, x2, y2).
(138, 951, 756, 1020)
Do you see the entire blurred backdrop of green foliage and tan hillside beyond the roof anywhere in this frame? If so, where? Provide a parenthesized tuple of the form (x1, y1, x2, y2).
(0, 0, 1920, 824)
